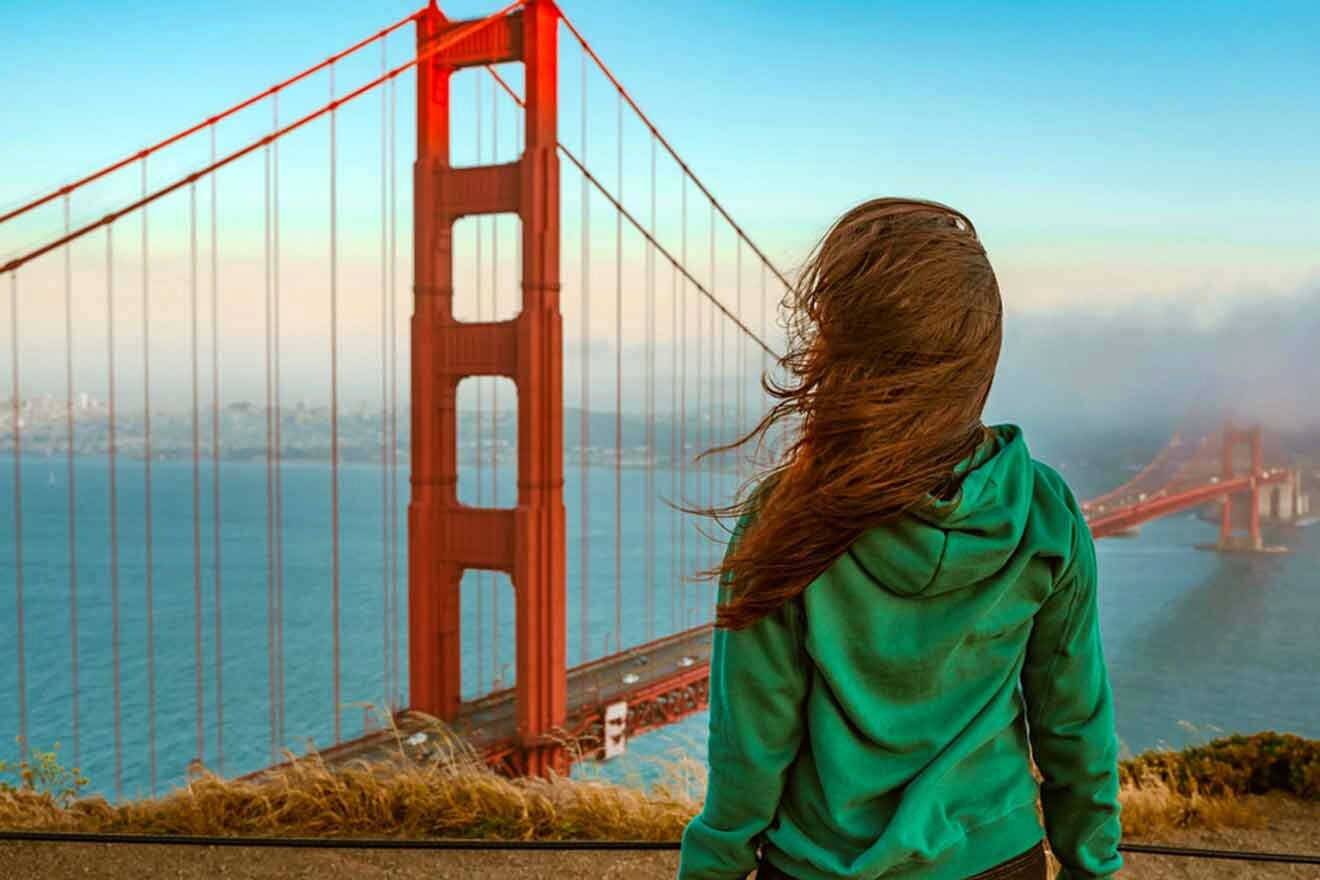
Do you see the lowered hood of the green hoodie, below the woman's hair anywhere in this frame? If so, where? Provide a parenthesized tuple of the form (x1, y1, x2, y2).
(849, 425, 1035, 596)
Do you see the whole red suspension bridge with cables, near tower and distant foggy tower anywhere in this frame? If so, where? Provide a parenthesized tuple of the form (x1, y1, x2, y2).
(0, 0, 1305, 797)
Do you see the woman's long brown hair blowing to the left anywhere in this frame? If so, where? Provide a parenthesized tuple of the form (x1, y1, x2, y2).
(682, 198, 1003, 629)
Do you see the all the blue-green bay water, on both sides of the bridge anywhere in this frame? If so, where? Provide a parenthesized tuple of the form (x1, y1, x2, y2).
(0, 456, 1320, 797)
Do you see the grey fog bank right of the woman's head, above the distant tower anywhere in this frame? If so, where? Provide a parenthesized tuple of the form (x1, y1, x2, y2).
(987, 282, 1320, 430)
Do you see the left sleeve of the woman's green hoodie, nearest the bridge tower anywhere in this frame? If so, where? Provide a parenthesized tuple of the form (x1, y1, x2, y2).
(678, 511, 807, 880)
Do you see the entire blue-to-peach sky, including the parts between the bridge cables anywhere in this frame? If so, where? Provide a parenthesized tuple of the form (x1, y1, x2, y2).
(0, 0, 1320, 427)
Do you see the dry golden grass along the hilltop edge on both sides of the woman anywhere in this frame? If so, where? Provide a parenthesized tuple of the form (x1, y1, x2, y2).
(0, 722, 1288, 840)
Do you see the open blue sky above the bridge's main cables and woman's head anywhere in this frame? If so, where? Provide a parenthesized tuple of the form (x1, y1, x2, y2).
(0, 0, 1320, 305)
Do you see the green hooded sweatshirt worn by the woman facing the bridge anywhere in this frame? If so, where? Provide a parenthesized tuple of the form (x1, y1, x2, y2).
(678, 425, 1122, 880)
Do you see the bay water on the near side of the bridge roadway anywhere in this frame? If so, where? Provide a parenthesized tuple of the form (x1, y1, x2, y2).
(611, 513, 1320, 780)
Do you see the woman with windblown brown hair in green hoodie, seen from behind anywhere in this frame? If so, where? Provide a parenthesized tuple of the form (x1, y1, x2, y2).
(678, 199, 1122, 880)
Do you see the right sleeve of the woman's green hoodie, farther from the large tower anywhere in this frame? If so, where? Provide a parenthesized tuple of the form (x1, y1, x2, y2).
(1022, 511, 1122, 880)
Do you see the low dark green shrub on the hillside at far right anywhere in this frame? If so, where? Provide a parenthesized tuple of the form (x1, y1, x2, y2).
(1119, 731, 1320, 801)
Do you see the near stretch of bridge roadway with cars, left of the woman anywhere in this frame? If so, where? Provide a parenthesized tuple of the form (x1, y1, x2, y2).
(243, 624, 713, 778)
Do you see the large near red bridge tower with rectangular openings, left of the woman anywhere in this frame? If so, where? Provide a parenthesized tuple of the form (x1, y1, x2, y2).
(408, 0, 568, 774)
